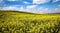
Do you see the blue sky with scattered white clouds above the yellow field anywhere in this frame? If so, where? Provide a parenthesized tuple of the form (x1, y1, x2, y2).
(0, 0, 60, 13)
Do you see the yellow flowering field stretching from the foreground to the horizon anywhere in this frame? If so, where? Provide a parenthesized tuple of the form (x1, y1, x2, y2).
(0, 11, 60, 33)
